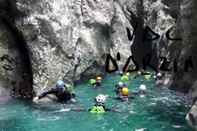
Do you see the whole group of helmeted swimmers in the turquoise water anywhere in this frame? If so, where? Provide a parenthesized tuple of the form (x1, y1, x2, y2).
(33, 71, 162, 113)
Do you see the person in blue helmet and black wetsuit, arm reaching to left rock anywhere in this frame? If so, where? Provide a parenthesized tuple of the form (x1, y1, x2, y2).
(33, 80, 75, 103)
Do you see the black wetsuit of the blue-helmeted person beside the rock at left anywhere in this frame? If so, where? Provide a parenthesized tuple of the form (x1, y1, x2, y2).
(38, 88, 75, 102)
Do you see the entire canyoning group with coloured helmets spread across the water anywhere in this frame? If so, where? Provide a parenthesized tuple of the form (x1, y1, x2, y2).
(33, 70, 162, 113)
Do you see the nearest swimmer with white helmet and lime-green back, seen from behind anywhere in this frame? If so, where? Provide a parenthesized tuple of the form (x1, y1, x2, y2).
(89, 94, 111, 113)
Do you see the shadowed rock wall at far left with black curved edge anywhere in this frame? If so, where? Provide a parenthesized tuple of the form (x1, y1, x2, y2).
(0, 0, 34, 100)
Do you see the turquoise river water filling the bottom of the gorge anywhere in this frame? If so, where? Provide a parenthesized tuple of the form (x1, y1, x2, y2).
(0, 76, 192, 131)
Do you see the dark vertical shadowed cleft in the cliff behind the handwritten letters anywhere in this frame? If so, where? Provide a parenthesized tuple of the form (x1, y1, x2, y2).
(118, 0, 158, 70)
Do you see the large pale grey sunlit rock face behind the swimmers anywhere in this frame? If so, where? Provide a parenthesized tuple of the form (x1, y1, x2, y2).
(13, 0, 132, 94)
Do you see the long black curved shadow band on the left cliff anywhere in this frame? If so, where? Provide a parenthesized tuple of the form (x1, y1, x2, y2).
(0, 0, 34, 99)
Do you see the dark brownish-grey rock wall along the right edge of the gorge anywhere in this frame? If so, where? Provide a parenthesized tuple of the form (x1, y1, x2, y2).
(152, 0, 197, 130)
